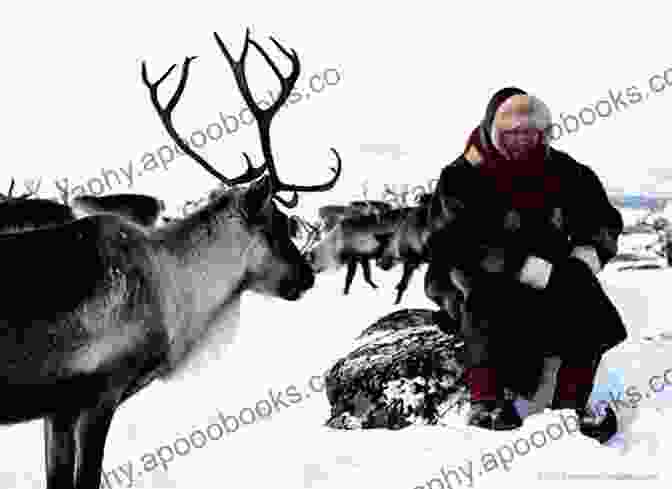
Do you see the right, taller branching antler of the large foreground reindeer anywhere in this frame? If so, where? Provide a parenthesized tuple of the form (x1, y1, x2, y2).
(214, 28, 342, 208)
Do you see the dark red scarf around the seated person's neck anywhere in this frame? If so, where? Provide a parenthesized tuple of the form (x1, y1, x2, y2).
(465, 126, 559, 210)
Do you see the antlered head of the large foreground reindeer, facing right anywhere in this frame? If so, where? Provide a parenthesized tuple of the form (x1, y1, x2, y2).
(142, 29, 341, 300)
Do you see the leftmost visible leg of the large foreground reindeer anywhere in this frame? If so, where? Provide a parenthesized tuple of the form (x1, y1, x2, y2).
(44, 413, 77, 489)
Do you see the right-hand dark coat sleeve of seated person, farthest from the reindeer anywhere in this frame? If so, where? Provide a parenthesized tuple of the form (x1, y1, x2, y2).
(567, 164, 623, 267)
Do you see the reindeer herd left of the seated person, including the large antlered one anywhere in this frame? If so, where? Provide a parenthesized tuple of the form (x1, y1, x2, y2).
(0, 29, 456, 489)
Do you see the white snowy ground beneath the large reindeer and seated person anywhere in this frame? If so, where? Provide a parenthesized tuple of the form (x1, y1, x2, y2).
(0, 258, 672, 489)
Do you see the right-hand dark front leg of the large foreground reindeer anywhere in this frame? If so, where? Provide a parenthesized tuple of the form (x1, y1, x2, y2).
(74, 392, 121, 489)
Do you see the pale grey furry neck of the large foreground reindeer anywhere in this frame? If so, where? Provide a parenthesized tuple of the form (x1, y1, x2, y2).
(152, 196, 254, 372)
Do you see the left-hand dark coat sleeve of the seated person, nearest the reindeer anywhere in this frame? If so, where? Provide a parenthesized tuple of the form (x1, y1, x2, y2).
(428, 163, 529, 277)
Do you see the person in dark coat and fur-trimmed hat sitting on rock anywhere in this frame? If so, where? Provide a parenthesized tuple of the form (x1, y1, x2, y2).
(429, 87, 627, 443)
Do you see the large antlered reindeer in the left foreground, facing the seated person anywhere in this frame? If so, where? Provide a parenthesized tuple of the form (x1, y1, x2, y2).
(0, 29, 341, 489)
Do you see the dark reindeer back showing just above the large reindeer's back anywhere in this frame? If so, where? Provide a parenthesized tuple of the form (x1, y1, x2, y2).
(70, 194, 166, 227)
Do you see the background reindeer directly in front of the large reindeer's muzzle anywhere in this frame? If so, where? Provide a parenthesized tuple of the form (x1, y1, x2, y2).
(307, 206, 405, 295)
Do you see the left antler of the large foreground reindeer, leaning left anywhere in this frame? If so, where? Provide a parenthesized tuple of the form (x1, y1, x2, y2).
(142, 56, 266, 185)
